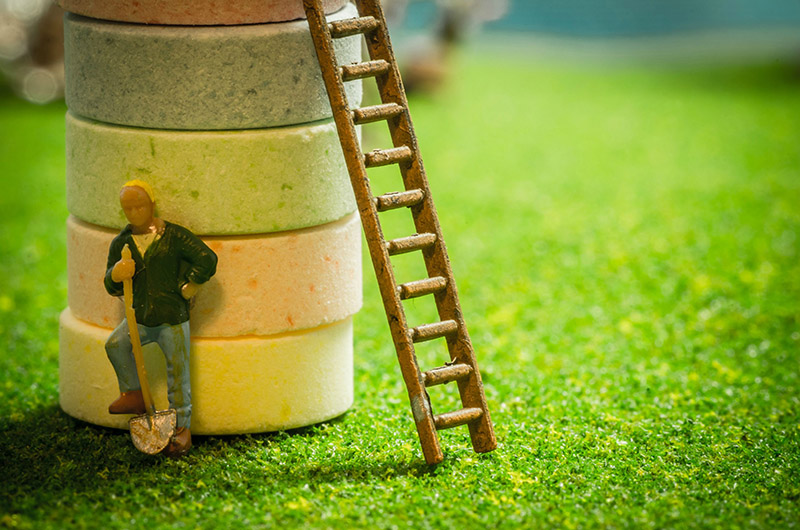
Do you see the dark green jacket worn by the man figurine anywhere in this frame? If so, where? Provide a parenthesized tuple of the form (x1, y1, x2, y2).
(104, 223, 217, 327)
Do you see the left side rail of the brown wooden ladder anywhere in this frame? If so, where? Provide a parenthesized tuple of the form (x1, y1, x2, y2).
(303, 0, 444, 464)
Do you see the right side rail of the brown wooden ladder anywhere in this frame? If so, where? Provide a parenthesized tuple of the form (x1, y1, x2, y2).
(356, 0, 497, 452)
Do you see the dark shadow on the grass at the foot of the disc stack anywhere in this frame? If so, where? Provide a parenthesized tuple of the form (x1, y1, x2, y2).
(0, 405, 435, 509)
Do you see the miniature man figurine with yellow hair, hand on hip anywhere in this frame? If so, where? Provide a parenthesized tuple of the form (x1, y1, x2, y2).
(104, 180, 217, 457)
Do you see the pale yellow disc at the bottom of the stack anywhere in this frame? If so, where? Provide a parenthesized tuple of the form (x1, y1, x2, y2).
(59, 309, 353, 434)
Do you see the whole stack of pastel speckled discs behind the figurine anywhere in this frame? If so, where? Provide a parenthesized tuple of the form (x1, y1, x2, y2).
(59, 0, 361, 434)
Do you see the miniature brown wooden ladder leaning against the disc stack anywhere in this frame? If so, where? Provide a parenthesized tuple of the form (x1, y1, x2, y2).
(303, 0, 497, 464)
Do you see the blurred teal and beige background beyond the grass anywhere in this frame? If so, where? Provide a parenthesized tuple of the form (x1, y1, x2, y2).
(0, 0, 800, 103)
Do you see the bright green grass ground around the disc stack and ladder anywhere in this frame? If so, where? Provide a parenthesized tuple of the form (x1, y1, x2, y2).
(0, 50, 800, 528)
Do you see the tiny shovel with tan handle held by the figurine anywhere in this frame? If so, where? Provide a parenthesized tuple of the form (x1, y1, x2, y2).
(122, 241, 178, 455)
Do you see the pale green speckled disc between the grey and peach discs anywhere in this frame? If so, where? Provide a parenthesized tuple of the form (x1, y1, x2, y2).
(66, 112, 356, 235)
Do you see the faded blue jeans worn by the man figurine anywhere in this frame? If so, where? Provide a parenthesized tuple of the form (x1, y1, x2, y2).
(106, 319, 192, 429)
